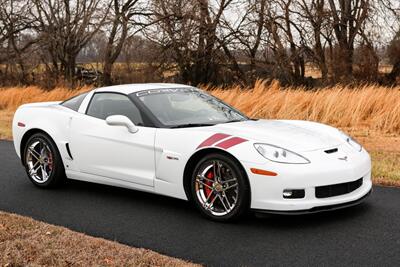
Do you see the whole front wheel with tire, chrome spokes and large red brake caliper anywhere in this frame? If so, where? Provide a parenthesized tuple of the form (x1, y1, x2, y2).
(191, 154, 250, 221)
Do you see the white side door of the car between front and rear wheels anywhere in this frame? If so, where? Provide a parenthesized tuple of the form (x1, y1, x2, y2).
(70, 93, 155, 186)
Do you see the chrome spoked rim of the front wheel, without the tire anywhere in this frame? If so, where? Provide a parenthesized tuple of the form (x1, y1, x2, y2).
(195, 160, 239, 216)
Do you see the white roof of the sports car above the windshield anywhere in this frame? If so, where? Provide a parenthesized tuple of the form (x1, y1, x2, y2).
(95, 83, 192, 95)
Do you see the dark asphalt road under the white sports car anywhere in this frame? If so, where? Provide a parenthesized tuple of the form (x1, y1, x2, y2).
(0, 141, 400, 266)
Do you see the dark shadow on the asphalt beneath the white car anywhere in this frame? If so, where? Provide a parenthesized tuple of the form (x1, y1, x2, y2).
(59, 177, 373, 230)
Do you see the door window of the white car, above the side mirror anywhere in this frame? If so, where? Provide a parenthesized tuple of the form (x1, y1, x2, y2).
(86, 93, 143, 125)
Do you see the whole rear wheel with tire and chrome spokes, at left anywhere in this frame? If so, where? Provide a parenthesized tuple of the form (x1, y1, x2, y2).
(23, 133, 65, 188)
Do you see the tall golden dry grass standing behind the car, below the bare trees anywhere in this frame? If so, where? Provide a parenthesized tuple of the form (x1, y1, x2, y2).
(0, 81, 400, 134)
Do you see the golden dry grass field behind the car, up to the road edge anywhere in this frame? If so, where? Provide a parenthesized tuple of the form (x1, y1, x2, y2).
(0, 81, 400, 185)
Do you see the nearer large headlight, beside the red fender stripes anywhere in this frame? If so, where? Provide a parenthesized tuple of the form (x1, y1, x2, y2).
(254, 144, 310, 164)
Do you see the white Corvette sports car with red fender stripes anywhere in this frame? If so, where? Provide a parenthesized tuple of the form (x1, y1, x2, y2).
(13, 84, 372, 221)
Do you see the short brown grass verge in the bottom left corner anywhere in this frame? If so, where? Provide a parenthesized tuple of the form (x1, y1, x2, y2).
(0, 212, 198, 267)
